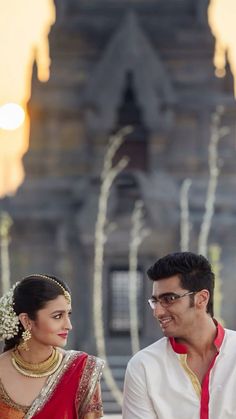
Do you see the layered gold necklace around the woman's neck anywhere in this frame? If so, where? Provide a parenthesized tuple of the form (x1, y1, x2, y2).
(11, 348, 62, 378)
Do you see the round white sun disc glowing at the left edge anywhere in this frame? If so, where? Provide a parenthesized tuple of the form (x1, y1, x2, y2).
(0, 103, 25, 130)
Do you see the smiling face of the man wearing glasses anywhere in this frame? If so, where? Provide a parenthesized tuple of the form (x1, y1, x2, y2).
(152, 275, 197, 338)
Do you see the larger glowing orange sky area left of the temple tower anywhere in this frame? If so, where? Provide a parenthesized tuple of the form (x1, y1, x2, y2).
(0, 0, 55, 197)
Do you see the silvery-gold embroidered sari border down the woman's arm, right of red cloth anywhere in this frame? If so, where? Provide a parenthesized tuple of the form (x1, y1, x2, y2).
(76, 355, 104, 417)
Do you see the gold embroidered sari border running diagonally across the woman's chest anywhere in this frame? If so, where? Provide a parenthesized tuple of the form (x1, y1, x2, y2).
(25, 350, 80, 419)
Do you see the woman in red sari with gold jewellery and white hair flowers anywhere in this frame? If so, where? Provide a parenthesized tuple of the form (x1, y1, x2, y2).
(0, 274, 103, 419)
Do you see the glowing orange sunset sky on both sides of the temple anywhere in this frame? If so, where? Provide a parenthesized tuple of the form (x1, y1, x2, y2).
(0, 0, 236, 197)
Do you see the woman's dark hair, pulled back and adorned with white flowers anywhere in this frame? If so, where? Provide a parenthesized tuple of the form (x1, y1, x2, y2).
(3, 274, 70, 352)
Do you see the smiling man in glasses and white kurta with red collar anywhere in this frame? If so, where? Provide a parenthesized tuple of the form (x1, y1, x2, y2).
(123, 252, 236, 419)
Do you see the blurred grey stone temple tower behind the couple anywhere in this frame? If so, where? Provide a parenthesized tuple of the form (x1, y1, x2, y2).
(2, 0, 236, 411)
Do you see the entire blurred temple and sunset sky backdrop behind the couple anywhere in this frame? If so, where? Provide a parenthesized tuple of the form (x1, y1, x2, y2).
(0, 0, 236, 414)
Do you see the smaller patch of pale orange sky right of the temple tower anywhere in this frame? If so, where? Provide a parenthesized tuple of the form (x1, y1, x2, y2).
(208, 0, 236, 97)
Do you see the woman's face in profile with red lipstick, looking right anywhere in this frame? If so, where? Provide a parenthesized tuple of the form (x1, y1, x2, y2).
(30, 295, 72, 347)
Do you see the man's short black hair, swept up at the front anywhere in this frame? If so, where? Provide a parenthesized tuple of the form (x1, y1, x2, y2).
(147, 252, 215, 317)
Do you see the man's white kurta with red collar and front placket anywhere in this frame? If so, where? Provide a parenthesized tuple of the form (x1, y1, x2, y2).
(123, 325, 236, 419)
